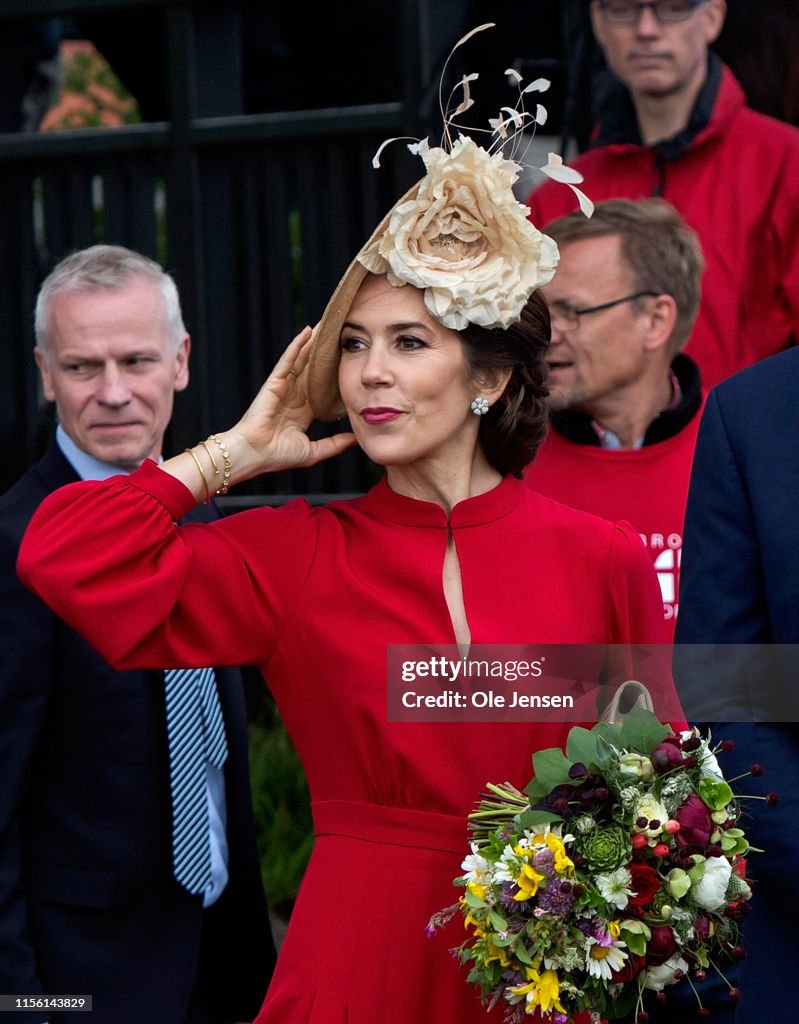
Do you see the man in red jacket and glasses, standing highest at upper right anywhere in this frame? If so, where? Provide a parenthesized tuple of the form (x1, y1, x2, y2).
(528, 0, 799, 386)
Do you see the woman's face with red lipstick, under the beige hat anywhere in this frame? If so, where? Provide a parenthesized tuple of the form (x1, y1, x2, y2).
(338, 275, 480, 466)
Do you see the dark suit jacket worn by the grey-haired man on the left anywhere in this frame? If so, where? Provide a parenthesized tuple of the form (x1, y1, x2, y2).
(0, 441, 275, 1024)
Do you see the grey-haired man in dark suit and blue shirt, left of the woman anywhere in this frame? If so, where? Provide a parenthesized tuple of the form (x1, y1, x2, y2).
(0, 246, 275, 1024)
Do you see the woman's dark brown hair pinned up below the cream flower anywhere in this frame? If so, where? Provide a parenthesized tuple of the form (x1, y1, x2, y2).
(459, 292, 550, 476)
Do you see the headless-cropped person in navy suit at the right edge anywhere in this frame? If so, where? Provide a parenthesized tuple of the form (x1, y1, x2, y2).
(675, 348, 799, 1024)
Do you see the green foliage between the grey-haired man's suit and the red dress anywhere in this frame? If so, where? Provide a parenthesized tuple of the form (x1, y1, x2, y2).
(250, 699, 313, 919)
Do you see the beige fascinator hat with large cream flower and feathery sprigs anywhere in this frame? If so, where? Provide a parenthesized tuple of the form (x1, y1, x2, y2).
(307, 25, 593, 421)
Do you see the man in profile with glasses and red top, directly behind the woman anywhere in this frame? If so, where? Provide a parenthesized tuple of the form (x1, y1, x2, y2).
(525, 199, 704, 631)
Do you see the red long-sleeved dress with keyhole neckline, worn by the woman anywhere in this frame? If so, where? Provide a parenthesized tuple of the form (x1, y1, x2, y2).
(19, 464, 664, 1024)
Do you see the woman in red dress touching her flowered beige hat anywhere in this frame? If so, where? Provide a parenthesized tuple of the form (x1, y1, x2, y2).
(19, 99, 665, 1024)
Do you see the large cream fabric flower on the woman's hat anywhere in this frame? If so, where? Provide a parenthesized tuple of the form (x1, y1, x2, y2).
(358, 136, 558, 331)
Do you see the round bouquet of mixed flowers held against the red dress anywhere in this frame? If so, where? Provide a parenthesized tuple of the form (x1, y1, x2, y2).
(428, 709, 776, 1024)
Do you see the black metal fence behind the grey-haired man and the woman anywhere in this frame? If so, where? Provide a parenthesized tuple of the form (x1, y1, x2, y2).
(0, 0, 577, 502)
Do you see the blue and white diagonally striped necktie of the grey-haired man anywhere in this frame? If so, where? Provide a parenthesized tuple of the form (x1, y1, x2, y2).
(164, 669, 227, 893)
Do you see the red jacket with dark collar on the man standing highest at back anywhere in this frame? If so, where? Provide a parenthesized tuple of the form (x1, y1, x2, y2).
(528, 57, 799, 387)
